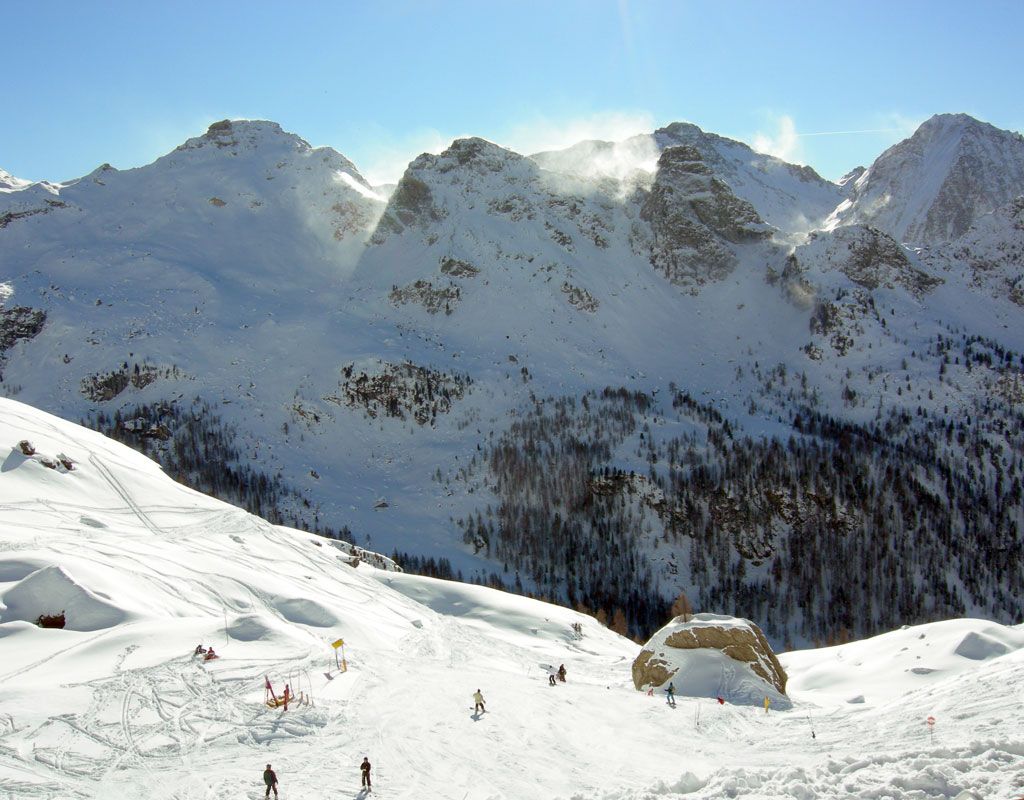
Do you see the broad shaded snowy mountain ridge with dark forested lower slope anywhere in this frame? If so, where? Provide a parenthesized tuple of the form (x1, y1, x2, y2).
(0, 113, 1024, 644)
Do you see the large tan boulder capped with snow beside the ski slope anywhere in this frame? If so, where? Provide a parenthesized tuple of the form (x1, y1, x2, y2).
(633, 614, 790, 708)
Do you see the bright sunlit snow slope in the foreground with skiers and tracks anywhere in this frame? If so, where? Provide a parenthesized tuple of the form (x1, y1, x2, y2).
(0, 399, 1024, 800)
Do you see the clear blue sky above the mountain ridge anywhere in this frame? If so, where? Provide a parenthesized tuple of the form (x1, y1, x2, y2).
(0, 0, 1024, 182)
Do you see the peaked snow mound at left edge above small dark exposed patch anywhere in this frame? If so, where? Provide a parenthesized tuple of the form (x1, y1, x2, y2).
(0, 565, 126, 631)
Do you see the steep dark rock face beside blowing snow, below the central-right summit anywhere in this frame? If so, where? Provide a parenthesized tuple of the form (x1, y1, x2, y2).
(640, 145, 771, 288)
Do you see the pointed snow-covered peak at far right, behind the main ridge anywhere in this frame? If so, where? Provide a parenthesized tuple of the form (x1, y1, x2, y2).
(829, 114, 1024, 245)
